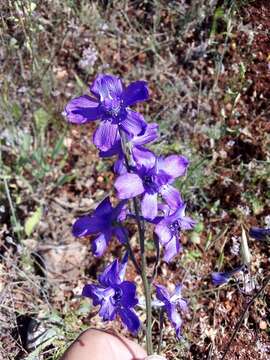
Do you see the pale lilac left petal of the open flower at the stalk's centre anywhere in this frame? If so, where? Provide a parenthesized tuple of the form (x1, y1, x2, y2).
(114, 173, 144, 199)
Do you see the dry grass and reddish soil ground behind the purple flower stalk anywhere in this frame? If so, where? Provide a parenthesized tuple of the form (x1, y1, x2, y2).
(0, 0, 270, 360)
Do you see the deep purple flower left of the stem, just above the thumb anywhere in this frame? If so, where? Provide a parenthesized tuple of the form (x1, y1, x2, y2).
(82, 255, 140, 333)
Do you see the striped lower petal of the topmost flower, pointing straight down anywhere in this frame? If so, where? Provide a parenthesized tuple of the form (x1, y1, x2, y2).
(93, 120, 119, 151)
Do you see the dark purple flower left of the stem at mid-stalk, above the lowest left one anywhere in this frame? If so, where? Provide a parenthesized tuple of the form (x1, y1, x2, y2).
(72, 197, 127, 256)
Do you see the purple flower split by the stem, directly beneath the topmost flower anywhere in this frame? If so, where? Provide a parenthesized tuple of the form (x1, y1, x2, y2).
(99, 123, 158, 175)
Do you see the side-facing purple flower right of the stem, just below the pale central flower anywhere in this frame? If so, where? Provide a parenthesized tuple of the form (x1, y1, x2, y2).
(155, 203, 195, 262)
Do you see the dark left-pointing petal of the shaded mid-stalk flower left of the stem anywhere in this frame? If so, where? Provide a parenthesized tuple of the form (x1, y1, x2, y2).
(72, 215, 106, 237)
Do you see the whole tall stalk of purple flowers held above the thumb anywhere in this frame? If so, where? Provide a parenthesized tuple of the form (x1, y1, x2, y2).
(64, 74, 195, 355)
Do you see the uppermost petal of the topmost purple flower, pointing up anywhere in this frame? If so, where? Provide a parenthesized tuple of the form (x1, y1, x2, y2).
(91, 74, 123, 101)
